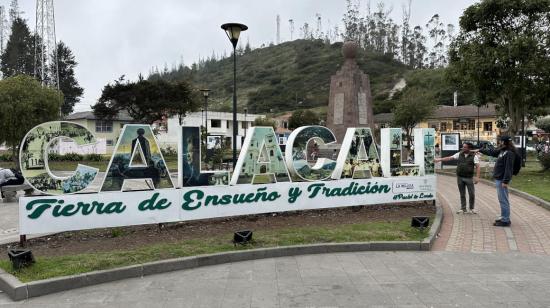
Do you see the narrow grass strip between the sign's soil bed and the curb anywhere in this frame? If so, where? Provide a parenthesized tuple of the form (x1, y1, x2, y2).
(0, 217, 433, 282)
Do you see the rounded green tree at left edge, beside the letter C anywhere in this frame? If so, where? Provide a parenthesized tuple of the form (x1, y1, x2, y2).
(0, 75, 63, 161)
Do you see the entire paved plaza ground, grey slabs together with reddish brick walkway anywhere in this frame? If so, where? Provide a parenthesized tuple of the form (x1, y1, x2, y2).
(0, 176, 550, 308)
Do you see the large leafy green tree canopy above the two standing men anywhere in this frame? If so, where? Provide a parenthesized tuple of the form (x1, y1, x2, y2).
(449, 0, 550, 134)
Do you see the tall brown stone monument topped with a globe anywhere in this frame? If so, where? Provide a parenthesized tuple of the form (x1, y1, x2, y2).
(326, 42, 374, 143)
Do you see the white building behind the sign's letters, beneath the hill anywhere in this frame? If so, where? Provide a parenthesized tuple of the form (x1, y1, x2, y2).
(156, 111, 265, 149)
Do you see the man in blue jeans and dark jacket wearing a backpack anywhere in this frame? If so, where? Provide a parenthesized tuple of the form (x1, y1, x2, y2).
(479, 136, 517, 227)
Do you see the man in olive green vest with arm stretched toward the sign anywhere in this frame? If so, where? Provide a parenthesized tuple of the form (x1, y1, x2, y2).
(435, 142, 481, 214)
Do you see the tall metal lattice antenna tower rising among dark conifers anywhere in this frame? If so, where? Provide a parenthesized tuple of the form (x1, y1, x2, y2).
(34, 0, 59, 89)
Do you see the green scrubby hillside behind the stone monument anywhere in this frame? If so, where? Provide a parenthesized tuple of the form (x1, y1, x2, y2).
(150, 40, 410, 113)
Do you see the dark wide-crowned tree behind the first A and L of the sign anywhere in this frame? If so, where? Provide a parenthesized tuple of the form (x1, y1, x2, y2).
(92, 76, 200, 123)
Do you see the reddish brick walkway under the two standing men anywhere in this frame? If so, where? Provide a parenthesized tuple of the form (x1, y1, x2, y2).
(433, 176, 550, 255)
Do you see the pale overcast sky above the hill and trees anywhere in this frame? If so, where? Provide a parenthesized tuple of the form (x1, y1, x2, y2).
(11, 0, 477, 111)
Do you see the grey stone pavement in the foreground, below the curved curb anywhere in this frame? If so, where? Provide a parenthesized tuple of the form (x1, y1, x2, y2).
(0, 251, 550, 308)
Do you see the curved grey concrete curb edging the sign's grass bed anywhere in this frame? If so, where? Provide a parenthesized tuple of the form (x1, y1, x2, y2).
(0, 202, 443, 301)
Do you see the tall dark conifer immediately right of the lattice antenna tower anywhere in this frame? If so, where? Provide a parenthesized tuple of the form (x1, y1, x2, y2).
(57, 42, 84, 115)
